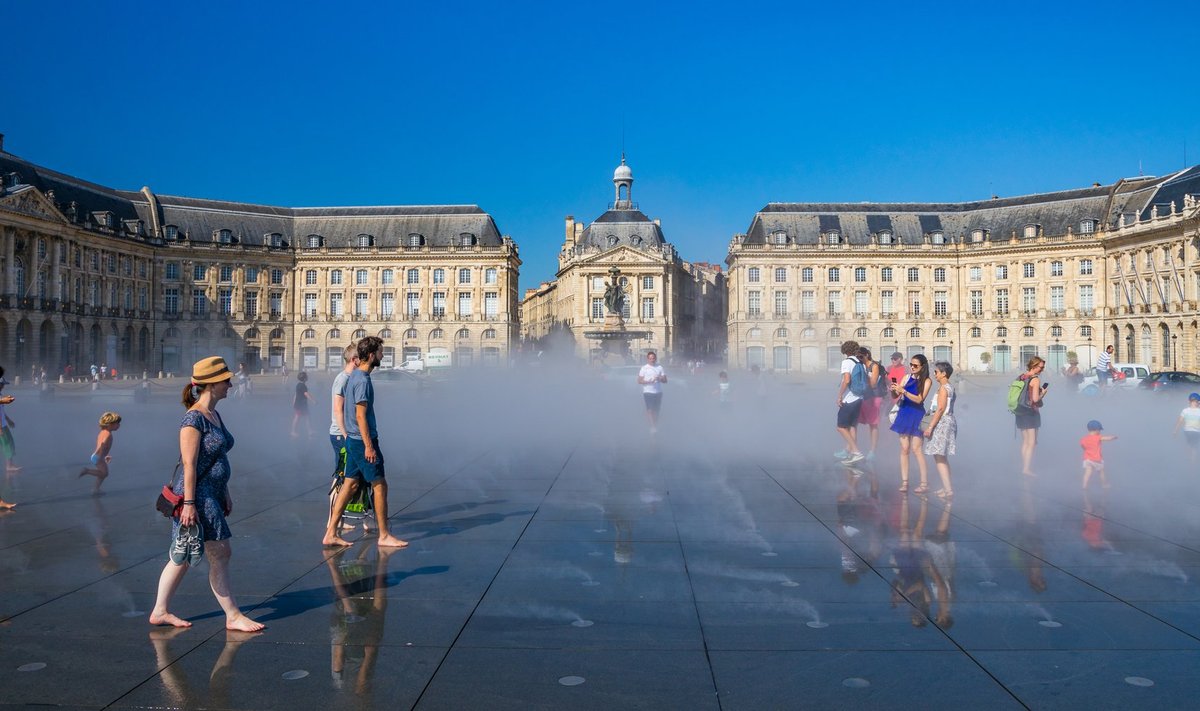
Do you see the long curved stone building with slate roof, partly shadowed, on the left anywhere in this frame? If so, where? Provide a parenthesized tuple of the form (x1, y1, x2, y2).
(0, 143, 521, 372)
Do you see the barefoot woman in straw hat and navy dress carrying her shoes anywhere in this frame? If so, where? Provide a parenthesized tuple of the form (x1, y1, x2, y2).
(150, 356, 264, 632)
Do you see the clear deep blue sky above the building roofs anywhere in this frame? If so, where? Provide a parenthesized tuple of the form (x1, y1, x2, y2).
(0, 0, 1200, 287)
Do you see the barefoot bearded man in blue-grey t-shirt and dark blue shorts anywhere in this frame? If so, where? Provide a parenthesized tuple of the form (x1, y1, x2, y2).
(323, 336, 408, 548)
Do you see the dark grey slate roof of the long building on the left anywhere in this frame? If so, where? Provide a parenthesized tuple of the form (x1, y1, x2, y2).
(0, 151, 503, 249)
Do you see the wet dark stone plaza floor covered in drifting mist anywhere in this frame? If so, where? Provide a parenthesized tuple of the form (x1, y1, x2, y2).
(0, 372, 1200, 710)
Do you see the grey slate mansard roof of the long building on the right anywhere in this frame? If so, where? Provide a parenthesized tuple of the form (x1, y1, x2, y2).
(744, 171, 1200, 245)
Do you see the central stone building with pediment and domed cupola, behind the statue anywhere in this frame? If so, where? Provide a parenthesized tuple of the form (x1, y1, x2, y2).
(522, 157, 725, 362)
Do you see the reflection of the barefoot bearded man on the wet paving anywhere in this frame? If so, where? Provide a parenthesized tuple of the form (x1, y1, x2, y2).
(325, 545, 398, 705)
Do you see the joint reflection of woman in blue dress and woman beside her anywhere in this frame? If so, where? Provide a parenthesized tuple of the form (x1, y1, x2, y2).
(892, 496, 953, 627)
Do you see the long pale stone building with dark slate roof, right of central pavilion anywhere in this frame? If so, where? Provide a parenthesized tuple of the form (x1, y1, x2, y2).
(726, 168, 1200, 371)
